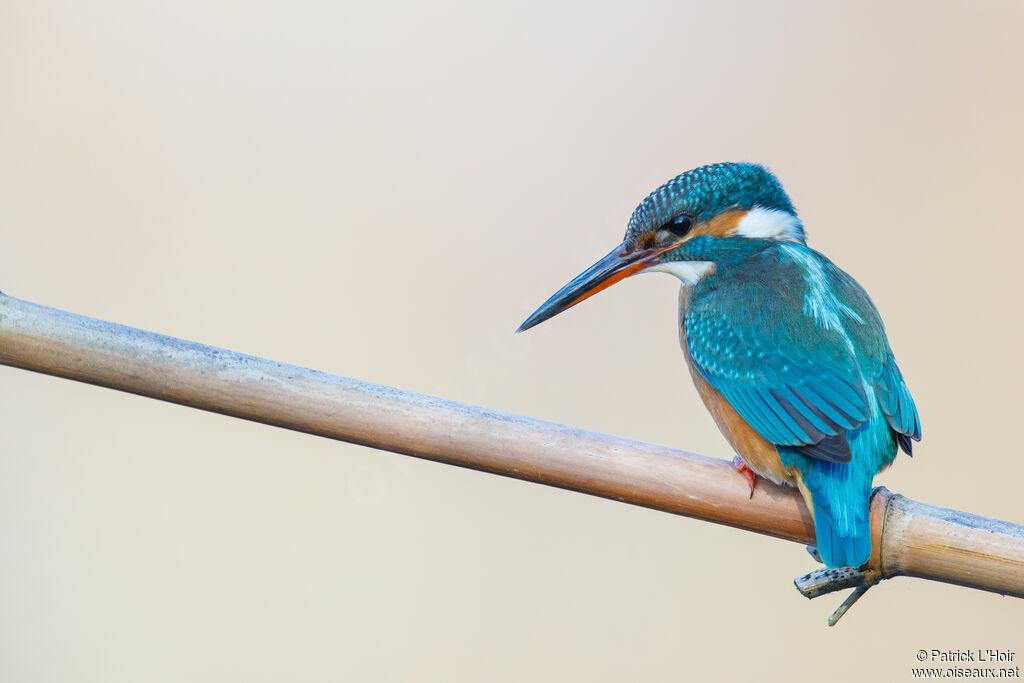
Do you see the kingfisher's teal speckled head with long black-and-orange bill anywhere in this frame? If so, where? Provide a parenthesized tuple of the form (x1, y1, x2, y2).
(516, 163, 804, 332)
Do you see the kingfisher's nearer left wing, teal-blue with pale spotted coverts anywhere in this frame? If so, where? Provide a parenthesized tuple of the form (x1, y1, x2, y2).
(683, 258, 870, 462)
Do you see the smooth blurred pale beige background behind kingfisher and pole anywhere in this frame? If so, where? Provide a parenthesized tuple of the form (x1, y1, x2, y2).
(0, 0, 1024, 682)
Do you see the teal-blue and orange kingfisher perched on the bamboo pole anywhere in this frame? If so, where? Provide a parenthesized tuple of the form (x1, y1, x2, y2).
(517, 163, 921, 567)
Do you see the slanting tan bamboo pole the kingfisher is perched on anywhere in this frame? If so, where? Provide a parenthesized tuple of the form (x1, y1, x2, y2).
(0, 294, 1024, 604)
